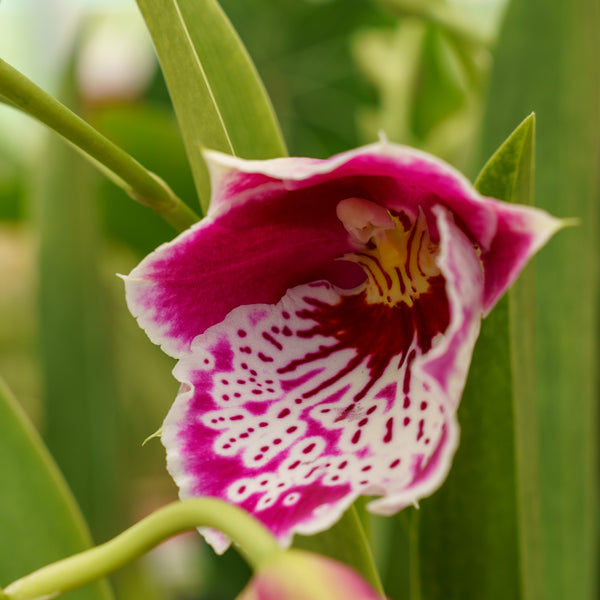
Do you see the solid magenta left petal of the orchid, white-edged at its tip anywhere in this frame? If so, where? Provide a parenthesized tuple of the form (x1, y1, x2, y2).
(125, 164, 364, 357)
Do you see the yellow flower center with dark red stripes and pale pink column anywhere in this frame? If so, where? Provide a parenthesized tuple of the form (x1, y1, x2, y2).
(337, 198, 440, 307)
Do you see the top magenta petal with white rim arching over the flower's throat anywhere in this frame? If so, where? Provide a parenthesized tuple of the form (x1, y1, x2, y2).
(207, 141, 496, 249)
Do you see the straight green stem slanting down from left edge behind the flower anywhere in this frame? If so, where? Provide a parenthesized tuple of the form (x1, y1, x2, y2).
(0, 59, 199, 231)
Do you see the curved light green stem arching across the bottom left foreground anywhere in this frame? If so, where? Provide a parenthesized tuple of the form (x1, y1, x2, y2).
(0, 498, 282, 600)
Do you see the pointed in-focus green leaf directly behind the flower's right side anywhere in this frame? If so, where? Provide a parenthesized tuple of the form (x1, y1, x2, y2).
(420, 116, 541, 600)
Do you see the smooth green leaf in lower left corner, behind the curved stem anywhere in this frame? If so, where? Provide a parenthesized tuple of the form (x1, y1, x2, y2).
(0, 379, 112, 600)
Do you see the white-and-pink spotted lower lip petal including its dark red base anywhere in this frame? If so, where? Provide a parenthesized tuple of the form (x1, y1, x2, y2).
(162, 207, 483, 551)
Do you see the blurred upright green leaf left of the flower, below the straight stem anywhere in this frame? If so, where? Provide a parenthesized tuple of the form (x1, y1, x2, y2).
(36, 124, 122, 540)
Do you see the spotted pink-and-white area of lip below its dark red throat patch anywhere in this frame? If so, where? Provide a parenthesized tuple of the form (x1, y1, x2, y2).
(163, 282, 446, 541)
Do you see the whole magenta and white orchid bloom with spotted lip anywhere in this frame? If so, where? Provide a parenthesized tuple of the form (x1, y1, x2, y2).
(125, 141, 561, 552)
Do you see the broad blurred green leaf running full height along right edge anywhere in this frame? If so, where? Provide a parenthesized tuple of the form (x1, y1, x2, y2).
(483, 0, 600, 600)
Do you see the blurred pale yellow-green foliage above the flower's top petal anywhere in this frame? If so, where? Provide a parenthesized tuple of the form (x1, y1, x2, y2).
(354, 0, 506, 169)
